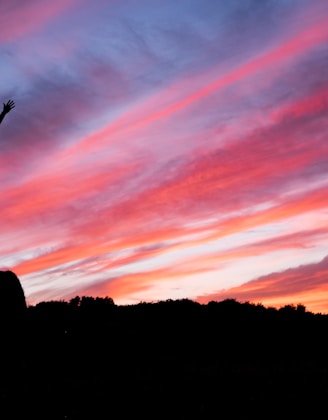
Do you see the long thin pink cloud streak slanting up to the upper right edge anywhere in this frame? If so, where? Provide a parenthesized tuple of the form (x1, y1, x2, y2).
(55, 13, 328, 161)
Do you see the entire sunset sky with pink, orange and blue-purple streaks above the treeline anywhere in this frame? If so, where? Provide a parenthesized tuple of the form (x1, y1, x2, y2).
(0, 0, 328, 313)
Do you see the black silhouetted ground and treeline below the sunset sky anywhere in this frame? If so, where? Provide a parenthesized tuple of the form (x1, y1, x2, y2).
(0, 297, 328, 420)
